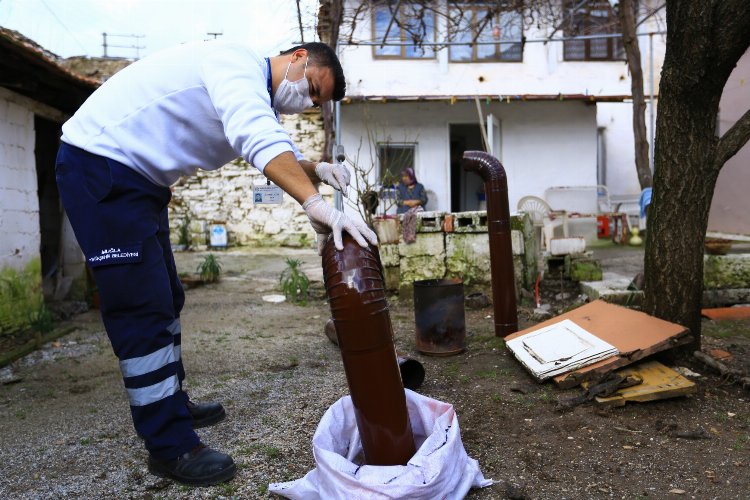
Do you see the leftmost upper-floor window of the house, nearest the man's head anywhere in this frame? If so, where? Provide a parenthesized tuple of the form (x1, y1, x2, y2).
(372, 2, 435, 59)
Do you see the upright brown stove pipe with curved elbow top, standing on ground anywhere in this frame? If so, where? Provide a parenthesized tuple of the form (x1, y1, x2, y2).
(461, 151, 518, 337)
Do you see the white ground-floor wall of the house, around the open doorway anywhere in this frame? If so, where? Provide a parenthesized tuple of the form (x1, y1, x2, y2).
(341, 101, 596, 211)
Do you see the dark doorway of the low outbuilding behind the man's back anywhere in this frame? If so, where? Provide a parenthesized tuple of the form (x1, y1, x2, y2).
(34, 116, 62, 292)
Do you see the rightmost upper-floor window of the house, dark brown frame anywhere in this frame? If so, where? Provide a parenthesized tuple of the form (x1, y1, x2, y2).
(563, 0, 625, 61)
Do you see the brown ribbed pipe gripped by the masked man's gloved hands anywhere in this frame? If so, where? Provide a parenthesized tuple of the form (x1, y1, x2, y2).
(323, 235, 416, 465)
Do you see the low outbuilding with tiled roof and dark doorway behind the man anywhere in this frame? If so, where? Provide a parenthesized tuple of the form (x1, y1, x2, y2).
(0, 27, 98, 297)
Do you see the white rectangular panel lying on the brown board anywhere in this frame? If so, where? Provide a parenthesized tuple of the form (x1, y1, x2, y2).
(506, 319, 617, 381)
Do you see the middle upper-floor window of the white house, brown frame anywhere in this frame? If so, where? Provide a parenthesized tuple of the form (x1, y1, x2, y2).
(450, 2, 523, 62)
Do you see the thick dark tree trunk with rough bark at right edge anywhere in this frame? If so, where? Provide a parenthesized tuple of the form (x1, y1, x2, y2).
(645, 0, 750, 351)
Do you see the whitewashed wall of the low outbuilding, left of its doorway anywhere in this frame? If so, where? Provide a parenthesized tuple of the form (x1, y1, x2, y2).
(0, 94, 40, 269)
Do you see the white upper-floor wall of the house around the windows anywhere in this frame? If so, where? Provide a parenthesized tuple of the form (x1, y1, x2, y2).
(341, 0, 665, 96)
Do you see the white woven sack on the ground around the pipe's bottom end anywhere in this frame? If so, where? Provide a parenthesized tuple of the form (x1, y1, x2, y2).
(268, 389, 492, 500)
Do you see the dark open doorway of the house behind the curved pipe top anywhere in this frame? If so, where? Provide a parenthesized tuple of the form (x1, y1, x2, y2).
(450, 124, 484, 212)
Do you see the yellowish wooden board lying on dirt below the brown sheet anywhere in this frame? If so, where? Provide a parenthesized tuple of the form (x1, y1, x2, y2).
(596, 361, 696, 406)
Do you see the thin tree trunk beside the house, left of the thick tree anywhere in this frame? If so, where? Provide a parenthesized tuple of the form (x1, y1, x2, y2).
(618, 0, 653, 189)
